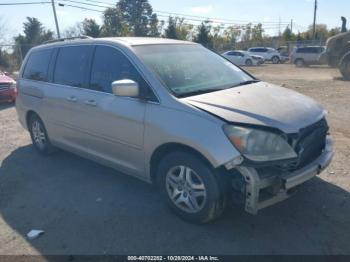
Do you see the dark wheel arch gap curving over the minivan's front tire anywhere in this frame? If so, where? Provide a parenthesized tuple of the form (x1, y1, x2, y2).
(150, 143, 214, 183)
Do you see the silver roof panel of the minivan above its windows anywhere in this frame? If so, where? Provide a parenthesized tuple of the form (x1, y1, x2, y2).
(40, 37, 195, 46)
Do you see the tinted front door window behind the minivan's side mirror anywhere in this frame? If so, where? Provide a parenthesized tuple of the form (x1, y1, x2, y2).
(90, 46, 148, 93)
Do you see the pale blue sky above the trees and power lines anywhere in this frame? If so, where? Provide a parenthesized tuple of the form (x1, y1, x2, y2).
(0, 0, 350, 42)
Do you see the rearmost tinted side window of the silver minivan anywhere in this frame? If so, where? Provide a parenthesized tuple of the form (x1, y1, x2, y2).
(23, 49, 52, 81)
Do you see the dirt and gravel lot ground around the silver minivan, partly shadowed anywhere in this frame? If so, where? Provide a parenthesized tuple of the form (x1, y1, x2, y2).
(0, 62, 350, 255)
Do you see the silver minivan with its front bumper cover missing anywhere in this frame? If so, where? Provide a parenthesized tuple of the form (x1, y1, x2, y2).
(16, 38, 333, 223)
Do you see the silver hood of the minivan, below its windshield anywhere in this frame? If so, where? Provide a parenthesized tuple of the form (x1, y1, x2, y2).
(183, 82, 324, 134)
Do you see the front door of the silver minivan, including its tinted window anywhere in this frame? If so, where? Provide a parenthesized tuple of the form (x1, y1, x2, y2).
(67, 45, 148, 176)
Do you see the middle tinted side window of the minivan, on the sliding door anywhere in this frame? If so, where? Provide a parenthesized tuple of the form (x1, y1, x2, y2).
(54, 45, 92, 87)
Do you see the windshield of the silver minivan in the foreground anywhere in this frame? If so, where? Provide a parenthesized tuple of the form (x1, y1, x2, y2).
(134, 44, 254, 97)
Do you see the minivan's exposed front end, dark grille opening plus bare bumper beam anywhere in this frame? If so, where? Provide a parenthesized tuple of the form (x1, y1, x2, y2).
(232, 120, 334, 215)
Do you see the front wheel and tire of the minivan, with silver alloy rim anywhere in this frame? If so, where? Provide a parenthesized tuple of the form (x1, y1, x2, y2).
(157, 152, 228, 224)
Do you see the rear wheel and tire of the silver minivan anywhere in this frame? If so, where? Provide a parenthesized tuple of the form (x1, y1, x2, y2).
(28, 114, 56, 155)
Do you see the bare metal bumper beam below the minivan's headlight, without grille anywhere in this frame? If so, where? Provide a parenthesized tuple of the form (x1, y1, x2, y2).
(236, 138, 334, 215)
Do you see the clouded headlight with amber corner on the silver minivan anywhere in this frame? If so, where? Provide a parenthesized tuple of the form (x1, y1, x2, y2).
(224, 125, 297, 162)
